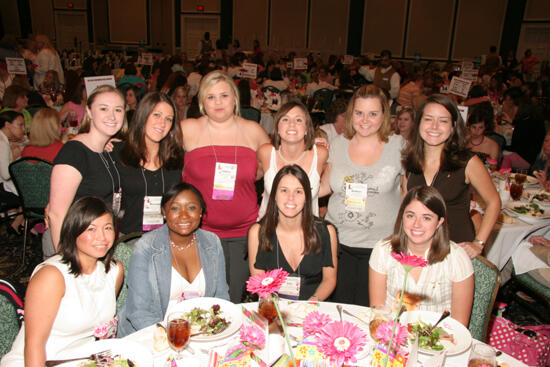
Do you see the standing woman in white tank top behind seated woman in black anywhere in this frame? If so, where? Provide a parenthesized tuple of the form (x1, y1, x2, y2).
(257, 101, 328, 219)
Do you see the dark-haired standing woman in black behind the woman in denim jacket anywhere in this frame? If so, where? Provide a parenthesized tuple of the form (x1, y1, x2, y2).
(113, 92, 183, 234)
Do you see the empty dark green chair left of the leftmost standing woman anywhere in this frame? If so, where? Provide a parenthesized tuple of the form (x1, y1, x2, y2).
(9, 157, 53, 267)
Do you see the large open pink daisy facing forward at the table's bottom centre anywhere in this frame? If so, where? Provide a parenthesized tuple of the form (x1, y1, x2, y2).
(317, 321, 367, 366)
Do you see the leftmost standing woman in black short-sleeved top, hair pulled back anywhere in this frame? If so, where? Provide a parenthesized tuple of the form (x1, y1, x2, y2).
(42, 85, 126, 258)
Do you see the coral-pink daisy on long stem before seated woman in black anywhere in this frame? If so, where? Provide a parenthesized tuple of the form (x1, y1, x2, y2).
(246, 269, 298, 367)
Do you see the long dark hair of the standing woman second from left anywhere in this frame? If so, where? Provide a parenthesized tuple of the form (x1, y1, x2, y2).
(120, 92, 183, 169)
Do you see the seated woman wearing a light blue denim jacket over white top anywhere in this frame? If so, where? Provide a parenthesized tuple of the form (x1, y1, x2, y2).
(117, 182, 229, 337)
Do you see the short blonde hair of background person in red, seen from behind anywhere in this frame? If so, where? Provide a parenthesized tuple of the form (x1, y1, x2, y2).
(29, 108, 61, 147)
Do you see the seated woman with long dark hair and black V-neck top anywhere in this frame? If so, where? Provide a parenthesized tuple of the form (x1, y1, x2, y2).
(248, 165, 338, 301)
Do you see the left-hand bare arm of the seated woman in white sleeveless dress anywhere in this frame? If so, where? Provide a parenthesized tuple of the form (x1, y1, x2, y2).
(25, 266, 65, 367)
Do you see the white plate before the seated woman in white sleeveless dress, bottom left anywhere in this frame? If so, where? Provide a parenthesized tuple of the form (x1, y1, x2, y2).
(56, 339, 153, 367)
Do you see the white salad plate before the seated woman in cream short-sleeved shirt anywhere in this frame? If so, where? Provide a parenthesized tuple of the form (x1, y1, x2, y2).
(400, 311, 472, 355)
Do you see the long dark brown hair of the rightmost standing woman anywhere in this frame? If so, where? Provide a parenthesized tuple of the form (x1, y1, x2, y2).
(401, 94, 470, 174)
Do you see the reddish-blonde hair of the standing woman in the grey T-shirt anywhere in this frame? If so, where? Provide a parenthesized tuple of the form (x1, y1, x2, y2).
(344, 84, 391, 142)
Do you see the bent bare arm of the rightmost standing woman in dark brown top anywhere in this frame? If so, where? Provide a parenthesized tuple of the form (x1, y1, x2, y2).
(459, 156, 500, 259)
